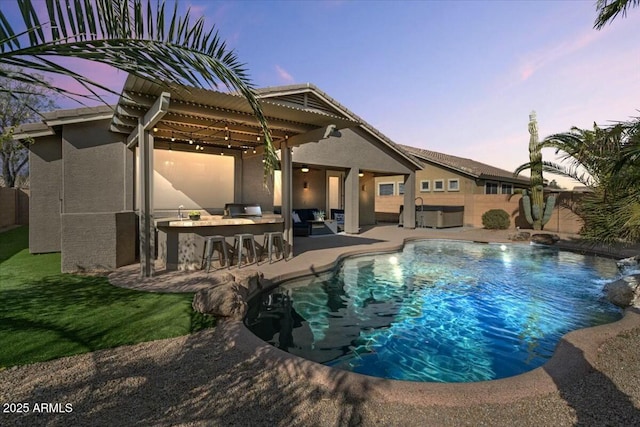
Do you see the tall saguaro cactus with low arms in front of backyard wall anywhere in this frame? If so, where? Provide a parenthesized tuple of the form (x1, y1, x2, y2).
(522, 111, 556, 230)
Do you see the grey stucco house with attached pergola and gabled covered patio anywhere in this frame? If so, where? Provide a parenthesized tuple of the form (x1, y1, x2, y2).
(15, 76, 421, 276)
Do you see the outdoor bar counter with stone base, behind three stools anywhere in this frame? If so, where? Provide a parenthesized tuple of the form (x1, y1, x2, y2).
(156, 214, 284, 270)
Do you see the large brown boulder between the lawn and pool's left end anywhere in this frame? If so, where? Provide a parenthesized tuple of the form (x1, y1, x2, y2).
(191, 282, 249, 320)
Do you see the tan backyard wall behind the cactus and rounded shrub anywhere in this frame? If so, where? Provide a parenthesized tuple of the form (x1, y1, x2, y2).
(376, 191, 582, 234)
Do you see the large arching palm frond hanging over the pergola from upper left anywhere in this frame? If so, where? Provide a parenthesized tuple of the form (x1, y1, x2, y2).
(0, 0, 277, 172)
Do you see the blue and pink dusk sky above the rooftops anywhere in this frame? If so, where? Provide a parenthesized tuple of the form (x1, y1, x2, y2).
(5, 0, 640, 187)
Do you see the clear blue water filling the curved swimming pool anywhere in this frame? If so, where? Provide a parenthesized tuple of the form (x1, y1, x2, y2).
(246, 240, 621, 382)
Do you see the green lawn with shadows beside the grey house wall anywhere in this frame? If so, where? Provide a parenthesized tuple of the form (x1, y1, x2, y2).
(0, 227, 215, 369)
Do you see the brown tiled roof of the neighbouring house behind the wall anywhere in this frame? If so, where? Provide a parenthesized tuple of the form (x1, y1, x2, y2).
(401, 145, 529, 185)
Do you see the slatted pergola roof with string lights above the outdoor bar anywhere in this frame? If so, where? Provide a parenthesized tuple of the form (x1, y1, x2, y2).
(110, 75, 359, 150)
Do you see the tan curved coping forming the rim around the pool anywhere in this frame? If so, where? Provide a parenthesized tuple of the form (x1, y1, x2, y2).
(230, 237, 640, 406)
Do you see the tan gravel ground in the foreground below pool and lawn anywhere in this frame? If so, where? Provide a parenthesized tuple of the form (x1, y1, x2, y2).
(0, 326, 640, 426)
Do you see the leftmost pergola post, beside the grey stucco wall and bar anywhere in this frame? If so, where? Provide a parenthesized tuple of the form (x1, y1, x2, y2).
(138, 120, 155, 277)
